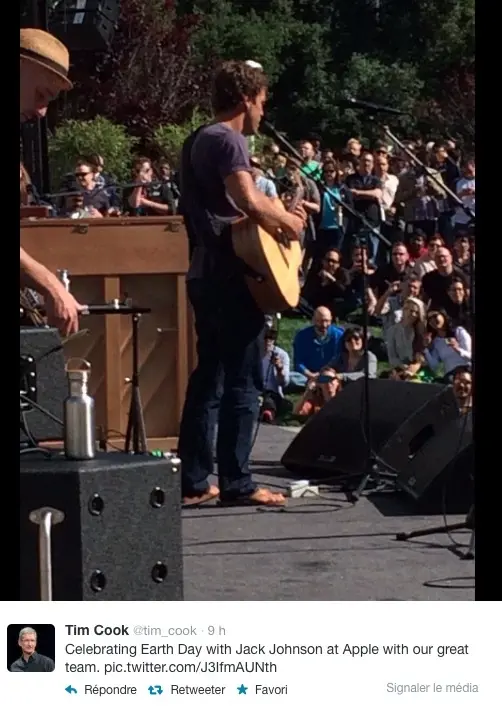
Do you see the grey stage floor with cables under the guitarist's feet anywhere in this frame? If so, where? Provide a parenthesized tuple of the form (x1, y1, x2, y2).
(183, 426, 474, 601)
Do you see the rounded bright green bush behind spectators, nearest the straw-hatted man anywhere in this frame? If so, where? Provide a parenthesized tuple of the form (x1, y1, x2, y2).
(49, 116, 137, 186)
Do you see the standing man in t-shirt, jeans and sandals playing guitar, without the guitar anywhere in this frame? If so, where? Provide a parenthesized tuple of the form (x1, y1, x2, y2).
(179, 62, 306, 506)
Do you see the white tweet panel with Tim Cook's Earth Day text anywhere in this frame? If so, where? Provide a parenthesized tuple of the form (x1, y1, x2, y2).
(2, 602, 502, 713)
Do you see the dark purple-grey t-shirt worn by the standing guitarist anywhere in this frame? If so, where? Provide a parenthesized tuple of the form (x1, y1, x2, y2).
(180, 124, 251, 279)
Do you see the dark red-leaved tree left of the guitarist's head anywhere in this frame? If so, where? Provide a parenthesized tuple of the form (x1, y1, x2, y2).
(64, 0, 208, 142)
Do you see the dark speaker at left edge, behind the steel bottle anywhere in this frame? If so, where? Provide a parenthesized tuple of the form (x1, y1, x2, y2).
(19, 327, 68, 443)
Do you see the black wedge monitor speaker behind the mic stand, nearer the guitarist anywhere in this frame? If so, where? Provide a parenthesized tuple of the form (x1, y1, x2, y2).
(281, 379, 458, 475)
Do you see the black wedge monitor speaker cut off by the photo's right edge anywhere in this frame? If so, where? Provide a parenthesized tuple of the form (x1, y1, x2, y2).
(397, 414, 474, 514)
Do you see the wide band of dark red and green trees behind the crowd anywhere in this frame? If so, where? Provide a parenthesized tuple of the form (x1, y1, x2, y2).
(53, 0, 475, 148)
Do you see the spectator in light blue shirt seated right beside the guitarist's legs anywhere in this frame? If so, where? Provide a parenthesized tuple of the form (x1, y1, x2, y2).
(261, 329, 290, 423)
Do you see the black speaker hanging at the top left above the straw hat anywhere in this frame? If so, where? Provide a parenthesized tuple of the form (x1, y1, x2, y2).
(49, 0, 120, 53)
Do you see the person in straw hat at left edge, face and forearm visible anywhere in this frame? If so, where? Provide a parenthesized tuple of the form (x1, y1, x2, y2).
(20, 28, 82, 335)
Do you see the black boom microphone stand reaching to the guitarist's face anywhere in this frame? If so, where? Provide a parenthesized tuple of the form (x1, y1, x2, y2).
(263, 121, 397, 504)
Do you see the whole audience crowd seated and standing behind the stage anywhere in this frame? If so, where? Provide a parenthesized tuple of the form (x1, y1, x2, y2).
(20, 131, 476, 422)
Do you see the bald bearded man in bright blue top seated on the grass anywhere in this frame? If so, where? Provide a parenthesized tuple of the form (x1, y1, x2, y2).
(290, 307, 343, 387)
